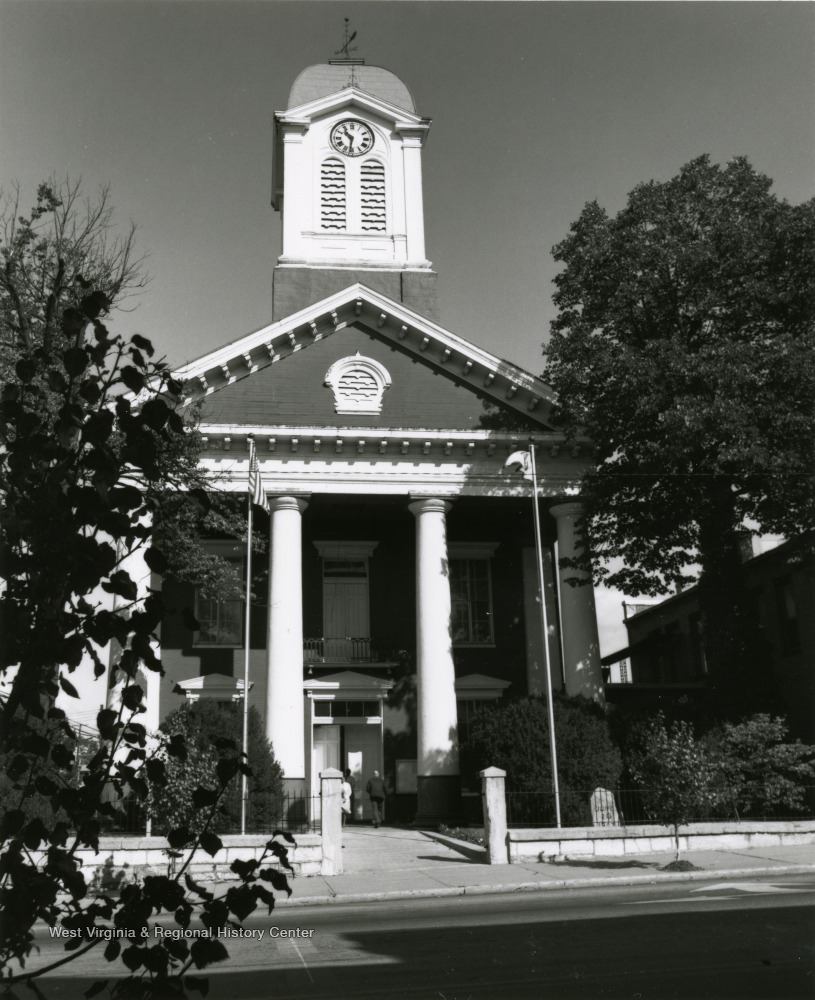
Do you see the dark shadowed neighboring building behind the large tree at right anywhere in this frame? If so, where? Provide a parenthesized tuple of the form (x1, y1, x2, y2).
(603, 539, 815, 741)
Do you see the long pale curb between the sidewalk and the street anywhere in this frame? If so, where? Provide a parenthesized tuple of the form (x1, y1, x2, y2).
(275, 864, 815, 910)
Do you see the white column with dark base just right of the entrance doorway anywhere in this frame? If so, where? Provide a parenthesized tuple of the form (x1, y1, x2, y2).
(410, 498, 460, 817)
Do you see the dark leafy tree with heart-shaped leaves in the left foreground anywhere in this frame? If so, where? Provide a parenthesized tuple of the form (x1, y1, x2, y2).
(0, 184, 288, 997)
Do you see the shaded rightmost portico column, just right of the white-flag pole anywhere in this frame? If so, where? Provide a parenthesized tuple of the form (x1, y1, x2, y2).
(550, 501, 605, 702)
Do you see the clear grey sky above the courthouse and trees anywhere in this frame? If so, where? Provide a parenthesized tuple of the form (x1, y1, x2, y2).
(0, 0, 815, 672)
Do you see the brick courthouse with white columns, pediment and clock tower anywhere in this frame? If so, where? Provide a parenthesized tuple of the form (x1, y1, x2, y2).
(131, 62, 603, 820)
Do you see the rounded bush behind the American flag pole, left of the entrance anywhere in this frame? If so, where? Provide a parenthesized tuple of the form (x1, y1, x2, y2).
(150, 701, 283, 833)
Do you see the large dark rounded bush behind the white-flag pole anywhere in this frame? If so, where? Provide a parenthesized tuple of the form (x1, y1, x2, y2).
(467, 695, 622, 824)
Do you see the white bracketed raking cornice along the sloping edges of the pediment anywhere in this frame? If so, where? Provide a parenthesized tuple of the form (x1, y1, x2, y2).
(175, 284, 554, 429)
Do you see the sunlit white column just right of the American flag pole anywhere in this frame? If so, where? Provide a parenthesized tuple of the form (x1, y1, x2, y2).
(266, 497, 307, 782)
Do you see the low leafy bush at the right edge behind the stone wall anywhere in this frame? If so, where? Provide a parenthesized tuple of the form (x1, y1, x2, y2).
(706, 713, 815, 816)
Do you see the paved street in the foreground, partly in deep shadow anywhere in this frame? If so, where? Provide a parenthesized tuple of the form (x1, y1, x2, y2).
(28, 875, 815, 1000)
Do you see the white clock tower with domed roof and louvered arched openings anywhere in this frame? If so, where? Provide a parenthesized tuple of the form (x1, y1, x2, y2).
(272, 60, 435, 316)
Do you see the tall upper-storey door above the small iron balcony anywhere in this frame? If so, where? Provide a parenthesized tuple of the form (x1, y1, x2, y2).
(323, 559, 370, 661)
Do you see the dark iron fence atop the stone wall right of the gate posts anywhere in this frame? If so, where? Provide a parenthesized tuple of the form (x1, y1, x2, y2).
(506, 786, 815, 828)
